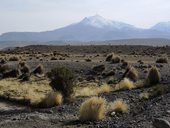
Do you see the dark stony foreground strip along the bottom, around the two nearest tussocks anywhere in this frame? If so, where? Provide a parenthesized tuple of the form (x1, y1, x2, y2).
(0, 86, 170, 128)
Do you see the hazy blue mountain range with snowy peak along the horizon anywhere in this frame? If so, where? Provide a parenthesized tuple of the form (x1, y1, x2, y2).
(0, 15, 170, 42)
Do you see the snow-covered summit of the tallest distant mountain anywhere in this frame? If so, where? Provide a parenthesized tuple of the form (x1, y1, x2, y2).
(80, 15, 134, 29)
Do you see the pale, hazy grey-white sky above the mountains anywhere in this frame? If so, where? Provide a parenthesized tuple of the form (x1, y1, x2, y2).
(0, 0, 170, 34)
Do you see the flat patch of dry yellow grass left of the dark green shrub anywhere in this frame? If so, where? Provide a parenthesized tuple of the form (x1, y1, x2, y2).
(0, 78, 52, 106)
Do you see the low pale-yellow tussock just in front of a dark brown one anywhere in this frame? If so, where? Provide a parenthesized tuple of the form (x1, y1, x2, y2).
(115, 78, 135, 90)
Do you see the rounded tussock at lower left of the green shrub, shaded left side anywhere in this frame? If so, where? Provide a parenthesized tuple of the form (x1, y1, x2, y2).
(39, 91, 63, 108)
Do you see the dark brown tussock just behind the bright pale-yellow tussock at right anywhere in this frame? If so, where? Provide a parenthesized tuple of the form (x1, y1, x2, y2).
(123, 67, 138, 82)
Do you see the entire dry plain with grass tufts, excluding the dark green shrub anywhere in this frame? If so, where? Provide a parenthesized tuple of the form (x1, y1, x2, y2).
(0, 45, 170, 128)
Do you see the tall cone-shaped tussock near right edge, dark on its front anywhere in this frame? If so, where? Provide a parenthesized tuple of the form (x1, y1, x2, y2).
(147, 67, 161, 86)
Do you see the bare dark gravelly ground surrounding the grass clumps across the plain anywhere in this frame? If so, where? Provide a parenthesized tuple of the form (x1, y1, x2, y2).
(0, 46, 170, 128)
